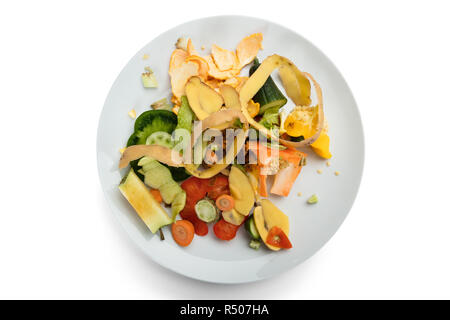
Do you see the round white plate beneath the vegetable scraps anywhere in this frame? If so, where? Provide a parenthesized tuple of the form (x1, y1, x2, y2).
(97, 16, 364, 283)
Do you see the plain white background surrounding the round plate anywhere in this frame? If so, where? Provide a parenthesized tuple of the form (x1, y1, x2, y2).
(0, 0, 450, 299)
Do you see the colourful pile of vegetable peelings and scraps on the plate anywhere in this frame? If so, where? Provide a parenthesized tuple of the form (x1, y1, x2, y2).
(119, 33, 331, 251)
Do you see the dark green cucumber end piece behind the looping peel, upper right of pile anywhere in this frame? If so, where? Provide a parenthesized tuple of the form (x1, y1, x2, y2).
(249, 58, 287, 115)
